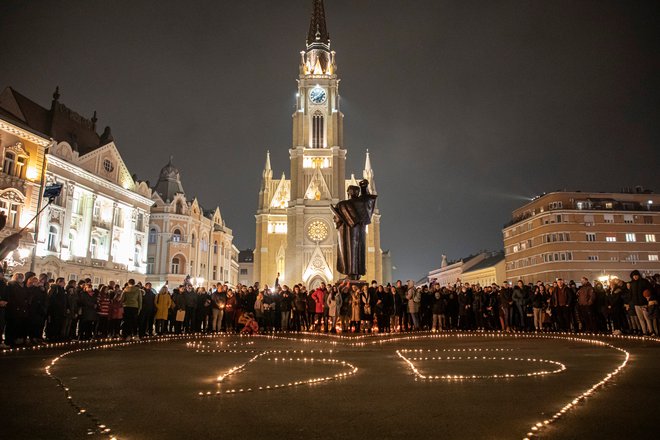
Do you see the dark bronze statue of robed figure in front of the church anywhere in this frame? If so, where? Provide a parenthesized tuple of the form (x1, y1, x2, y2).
(331, 180, 378, 280)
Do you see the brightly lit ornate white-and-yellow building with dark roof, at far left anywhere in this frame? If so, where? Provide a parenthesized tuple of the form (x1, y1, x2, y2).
(0, 87, 152, 284)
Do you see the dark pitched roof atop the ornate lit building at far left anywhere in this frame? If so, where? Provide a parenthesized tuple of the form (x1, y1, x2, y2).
(0, 87, 103, 155)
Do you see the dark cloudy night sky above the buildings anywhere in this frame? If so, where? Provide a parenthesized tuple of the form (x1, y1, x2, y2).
(0, 0, 660, 279)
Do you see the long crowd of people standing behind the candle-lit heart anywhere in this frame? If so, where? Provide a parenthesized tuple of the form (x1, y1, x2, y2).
(0, 271, 660, 348)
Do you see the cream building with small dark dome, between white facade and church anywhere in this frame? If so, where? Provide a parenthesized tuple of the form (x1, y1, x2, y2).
(147, 158, 238, 288)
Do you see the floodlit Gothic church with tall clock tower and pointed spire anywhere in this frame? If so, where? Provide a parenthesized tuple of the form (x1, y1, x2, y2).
(254, 0, 382, 288)
